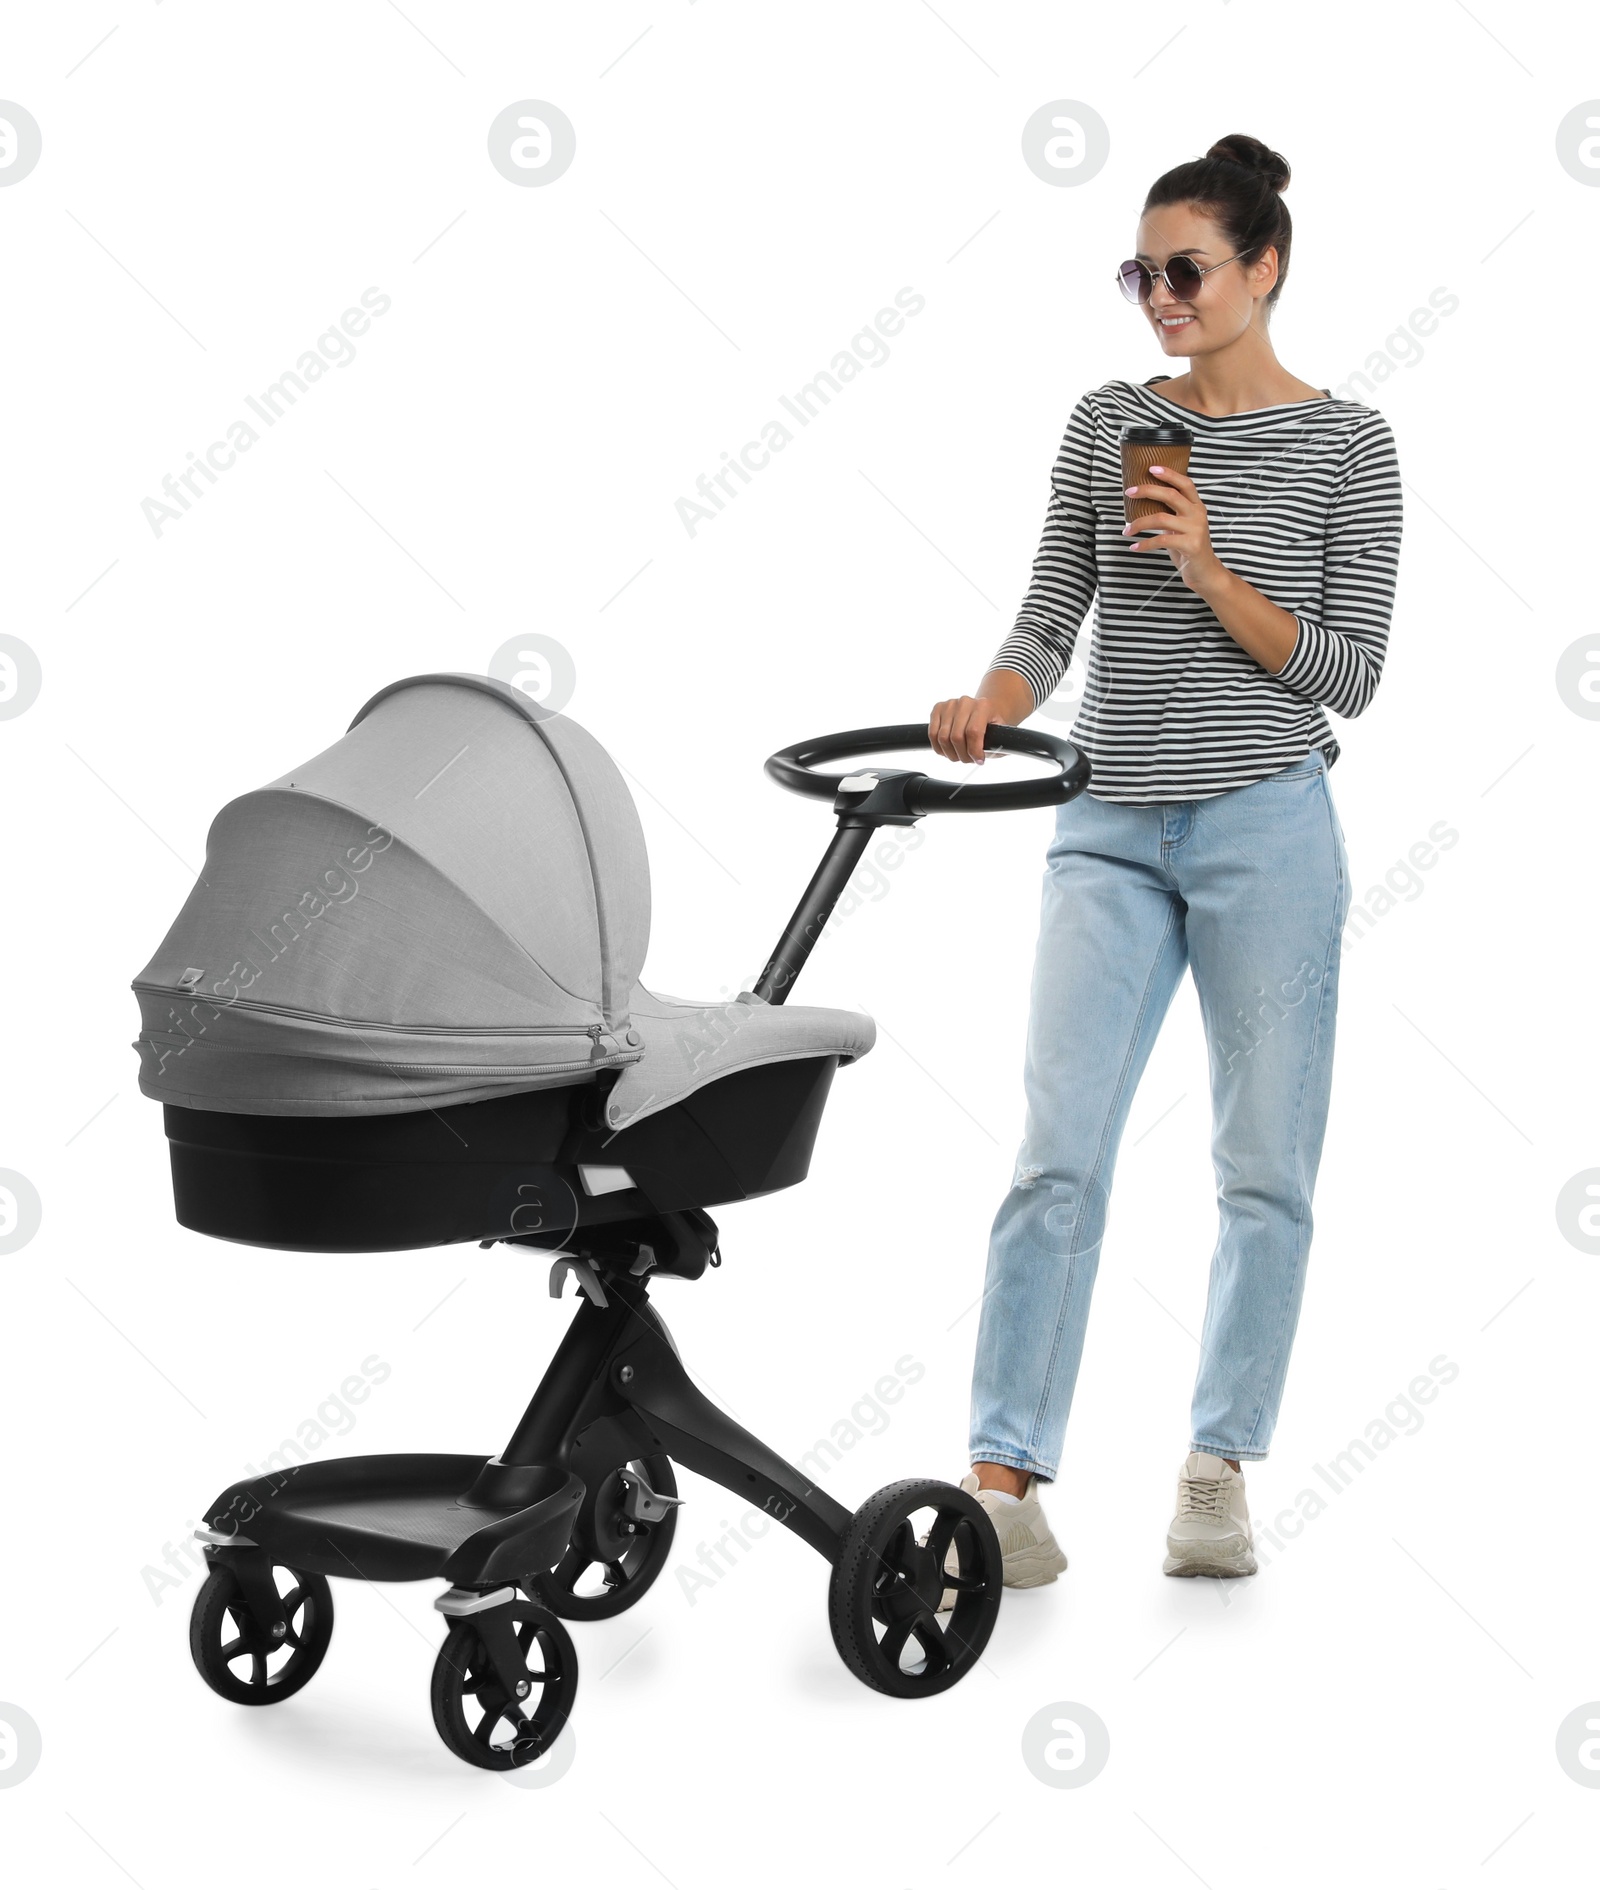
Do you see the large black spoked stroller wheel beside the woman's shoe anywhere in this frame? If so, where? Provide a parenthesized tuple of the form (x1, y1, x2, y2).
(827, 1476, 1001, 1699)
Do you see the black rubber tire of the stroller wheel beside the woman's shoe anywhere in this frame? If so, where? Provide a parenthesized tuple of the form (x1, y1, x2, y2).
(827, 1476, 1003, 1699)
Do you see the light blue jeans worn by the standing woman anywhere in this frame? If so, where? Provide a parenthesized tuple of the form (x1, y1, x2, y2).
(971, 750, 1351, 1480)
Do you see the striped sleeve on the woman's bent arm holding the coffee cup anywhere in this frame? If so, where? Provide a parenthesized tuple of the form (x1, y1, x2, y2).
(1277, 414, 1402, 716)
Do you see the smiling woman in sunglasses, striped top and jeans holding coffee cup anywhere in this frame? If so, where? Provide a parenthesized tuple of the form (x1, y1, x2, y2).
(929, 136, 1400, 1599)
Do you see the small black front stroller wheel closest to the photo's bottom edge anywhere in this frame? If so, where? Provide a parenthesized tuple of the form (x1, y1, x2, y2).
(431, 1595, 578, 1771)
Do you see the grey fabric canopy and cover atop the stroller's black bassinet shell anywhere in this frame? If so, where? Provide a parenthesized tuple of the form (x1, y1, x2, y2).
(134, 677, 873, 1126)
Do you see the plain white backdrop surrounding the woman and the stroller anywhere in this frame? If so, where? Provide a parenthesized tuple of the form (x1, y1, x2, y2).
(0, 0, 1600, 1890)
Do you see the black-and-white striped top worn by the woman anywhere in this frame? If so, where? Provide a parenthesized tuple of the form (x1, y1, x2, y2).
(990, 376, 1402, 807)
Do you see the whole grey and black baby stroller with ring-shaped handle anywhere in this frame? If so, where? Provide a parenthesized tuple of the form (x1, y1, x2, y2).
(134, 675, 1088, 1771)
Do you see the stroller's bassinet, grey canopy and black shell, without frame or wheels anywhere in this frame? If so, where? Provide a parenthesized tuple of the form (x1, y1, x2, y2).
(134, 677, 873, 1251)
